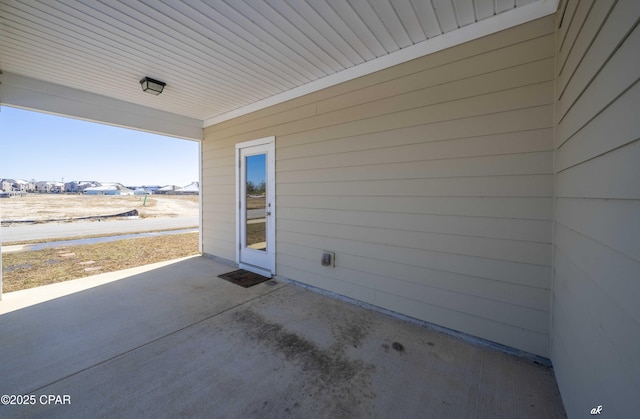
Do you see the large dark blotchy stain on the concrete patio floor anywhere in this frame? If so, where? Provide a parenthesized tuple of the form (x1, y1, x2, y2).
(233, 309, 375, 417)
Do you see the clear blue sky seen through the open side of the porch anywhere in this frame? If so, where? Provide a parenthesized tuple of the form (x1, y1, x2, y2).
(0, 106, 198, 186)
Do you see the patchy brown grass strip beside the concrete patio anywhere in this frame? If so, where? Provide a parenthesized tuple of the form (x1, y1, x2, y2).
(2, 233, 198, 292)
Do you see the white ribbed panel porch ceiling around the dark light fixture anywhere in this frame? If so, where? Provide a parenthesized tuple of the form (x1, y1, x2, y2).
(0, 0, 558, 135)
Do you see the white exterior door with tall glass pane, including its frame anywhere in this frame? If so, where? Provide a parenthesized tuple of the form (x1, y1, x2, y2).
(236, 137, 276, 277)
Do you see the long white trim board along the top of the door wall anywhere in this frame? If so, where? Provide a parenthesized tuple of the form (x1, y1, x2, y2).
(204, 0, 559, 128)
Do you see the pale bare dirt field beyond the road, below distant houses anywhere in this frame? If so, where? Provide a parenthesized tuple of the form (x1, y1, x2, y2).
(0, 194, 199, 222)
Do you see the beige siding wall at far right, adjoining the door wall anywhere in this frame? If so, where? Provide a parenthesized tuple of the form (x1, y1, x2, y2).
(551, 0, 640, 417)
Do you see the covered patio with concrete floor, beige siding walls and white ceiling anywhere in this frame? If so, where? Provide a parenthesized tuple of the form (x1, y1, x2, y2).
(0, 0, 640, 418)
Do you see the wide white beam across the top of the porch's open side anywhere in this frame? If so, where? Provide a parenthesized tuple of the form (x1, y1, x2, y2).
(0, 73, 204, 141)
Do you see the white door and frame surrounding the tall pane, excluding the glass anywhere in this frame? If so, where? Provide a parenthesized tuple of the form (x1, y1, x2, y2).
(236, 136, 276, 277)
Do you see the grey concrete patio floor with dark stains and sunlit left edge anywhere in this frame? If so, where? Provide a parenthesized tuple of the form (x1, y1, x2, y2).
(0, 257, 564, 418)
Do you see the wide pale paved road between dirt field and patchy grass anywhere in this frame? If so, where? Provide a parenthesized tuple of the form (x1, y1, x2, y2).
(2, 216, 199, 243)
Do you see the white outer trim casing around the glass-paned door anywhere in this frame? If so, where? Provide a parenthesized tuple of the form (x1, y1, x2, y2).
(235, 136, 277, 277)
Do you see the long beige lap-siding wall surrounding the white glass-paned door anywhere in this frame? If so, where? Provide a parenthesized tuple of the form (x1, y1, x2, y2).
(203, 17, 555, 356)
